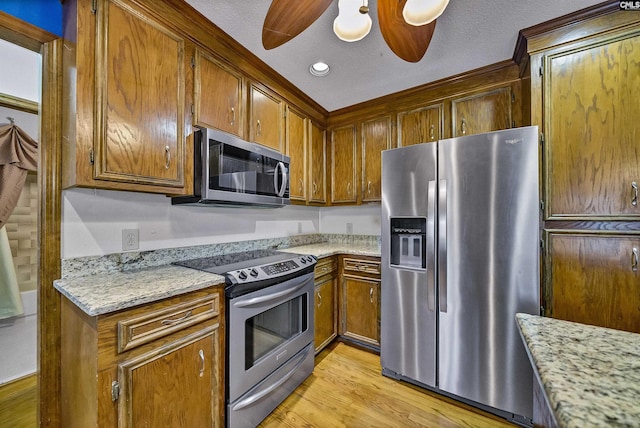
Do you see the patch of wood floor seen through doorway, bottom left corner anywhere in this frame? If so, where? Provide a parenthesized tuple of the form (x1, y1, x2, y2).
(0, 374, 38, 428)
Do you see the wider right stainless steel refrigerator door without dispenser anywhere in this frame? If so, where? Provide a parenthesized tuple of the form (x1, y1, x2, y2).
(438, 127, 540, 418)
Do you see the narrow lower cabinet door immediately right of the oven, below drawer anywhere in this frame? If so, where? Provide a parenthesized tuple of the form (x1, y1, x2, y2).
(314, 276, 338, 354)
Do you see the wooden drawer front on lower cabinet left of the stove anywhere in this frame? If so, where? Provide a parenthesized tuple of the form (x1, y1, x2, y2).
(118, 295, 220, 352)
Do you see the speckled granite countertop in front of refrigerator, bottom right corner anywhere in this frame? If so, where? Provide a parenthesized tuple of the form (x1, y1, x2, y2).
(516, 314, 640, 427)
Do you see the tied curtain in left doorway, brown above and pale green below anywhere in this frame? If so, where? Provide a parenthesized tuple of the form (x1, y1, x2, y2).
(0, 123, 38, 319)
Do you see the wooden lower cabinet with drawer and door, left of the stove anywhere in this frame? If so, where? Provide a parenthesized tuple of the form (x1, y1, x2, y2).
(61, 287, 224, 428)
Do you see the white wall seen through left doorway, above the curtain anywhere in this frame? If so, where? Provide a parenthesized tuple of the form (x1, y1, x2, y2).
(0, 40, 42, 102)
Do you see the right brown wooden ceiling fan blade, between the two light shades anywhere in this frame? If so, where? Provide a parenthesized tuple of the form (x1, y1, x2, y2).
(378, 0, 436, 62)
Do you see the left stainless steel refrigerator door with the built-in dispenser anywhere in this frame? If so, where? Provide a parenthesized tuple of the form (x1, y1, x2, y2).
(380, 143, 437, 386)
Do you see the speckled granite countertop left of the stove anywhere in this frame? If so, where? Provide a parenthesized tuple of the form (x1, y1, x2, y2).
(53, 265, 224, 316)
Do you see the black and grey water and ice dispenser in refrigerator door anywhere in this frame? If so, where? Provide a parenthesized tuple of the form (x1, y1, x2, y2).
(389, 217, 427, 269)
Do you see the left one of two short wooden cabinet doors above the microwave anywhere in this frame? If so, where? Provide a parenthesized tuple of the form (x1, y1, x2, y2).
(193, 49, 245, 137)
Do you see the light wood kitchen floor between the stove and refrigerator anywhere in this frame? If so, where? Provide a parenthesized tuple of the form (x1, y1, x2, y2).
(260, 342, 514, 428)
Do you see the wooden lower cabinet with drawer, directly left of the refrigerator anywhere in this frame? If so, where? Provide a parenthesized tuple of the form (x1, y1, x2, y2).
(340, 256, 380, 351)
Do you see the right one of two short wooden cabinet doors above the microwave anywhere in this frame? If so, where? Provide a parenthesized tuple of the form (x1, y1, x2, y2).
(250, 85, 284, 152)
